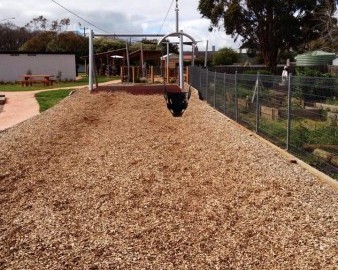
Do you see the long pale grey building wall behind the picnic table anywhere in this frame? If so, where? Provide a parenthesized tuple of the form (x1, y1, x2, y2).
(0, 53, 76, 82)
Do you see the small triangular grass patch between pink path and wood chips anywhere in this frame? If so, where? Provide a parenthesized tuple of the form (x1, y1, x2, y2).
(35, 89, 73, 112)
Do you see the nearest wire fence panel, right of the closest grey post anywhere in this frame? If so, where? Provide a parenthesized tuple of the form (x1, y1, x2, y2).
(289, 76, 338, 178)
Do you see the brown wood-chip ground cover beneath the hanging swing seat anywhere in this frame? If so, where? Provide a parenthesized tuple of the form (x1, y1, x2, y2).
(0, 89, 338, 270)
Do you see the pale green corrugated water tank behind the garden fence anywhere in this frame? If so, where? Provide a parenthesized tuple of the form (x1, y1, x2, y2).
(295, 51, 336, 66)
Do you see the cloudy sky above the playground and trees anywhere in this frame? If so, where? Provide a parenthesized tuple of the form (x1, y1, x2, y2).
(0, 0, 240, 50)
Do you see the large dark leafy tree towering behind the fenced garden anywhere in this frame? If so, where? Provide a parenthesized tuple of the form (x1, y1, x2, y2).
(198, 0, 335, 70)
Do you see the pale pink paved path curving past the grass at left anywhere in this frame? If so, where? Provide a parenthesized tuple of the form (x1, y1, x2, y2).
(0, 80, 121, 131)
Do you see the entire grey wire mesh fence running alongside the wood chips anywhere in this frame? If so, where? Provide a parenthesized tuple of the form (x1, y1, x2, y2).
(189, 67, 338, 179)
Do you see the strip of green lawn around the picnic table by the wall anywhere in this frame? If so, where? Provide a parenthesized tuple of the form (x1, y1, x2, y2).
(0, 76, 120, 92)
